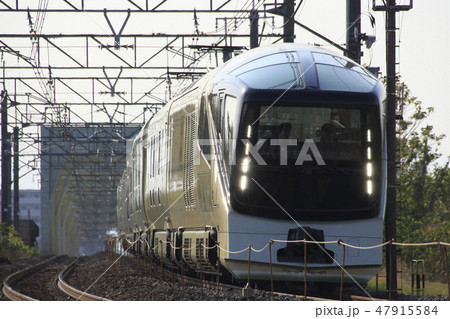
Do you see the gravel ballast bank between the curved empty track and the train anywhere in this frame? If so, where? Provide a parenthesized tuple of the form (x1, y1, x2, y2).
(67, 254, 390, 301)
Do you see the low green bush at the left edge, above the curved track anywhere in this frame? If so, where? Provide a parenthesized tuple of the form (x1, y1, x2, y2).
(0, 223, 38, 261)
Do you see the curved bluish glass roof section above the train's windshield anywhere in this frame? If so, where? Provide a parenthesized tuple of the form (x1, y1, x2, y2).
(214, 43, 380, 92)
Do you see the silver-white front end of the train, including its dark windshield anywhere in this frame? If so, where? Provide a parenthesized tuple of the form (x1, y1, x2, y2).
(211, 46, 386, 284)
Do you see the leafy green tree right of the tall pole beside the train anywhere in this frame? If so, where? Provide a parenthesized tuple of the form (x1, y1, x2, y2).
(397, 83, 450, 278)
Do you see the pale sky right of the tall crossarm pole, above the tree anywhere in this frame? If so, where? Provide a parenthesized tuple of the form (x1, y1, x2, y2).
(394, 0, 450, 163)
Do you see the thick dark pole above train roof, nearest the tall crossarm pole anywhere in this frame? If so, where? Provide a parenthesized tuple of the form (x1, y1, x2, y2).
(345, 0, 361, 64)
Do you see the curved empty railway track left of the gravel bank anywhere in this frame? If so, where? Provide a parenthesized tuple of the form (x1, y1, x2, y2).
(2, 256, 107, 301)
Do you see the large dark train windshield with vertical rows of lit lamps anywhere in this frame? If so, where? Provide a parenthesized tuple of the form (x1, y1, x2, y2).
(232, 103, 381, 219)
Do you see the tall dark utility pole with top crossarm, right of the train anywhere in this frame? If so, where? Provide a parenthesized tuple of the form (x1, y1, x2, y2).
(373, 0, 412, 293)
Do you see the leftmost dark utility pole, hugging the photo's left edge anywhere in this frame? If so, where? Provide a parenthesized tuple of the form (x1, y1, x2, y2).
(1, 90, 12, 226)
